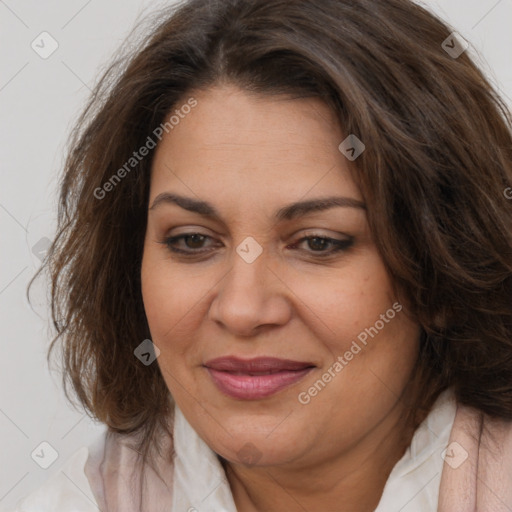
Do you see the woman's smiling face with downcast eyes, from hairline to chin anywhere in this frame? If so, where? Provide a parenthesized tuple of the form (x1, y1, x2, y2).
(142, 86, 419, 465)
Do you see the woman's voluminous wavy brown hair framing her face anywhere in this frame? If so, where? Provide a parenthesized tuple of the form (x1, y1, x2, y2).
(28, 0, 512, 466)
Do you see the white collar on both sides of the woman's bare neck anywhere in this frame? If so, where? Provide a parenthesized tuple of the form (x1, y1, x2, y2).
(172, 390, 456, 512)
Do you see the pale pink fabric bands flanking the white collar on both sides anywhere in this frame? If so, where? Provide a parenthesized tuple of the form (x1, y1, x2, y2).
(86, 394, 512, 512)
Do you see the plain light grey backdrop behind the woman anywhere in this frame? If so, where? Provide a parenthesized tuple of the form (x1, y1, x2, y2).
(0, 0, 512, 512)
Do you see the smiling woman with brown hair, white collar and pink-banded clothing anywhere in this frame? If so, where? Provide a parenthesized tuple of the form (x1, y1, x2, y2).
(19, 0, 512, 512)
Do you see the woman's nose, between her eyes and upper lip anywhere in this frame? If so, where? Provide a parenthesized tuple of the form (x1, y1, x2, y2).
(209, 247, 292, 337)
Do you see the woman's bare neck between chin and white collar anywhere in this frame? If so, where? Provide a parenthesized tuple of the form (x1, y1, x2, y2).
(223, 404, 413, 512)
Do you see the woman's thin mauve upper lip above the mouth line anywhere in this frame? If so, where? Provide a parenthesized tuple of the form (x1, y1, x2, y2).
(204, 356, 314, 373)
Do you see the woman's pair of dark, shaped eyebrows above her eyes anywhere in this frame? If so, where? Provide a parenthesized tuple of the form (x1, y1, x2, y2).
(149, 192, 366, 221)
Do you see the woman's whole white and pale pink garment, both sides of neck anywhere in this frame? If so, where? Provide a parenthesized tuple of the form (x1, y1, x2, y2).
(16, 390, 512, 512)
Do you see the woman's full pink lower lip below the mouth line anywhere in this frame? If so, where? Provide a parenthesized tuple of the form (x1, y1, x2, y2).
(207, 368, 313, 400)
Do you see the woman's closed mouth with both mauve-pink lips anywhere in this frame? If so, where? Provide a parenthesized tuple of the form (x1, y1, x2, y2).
(204, 356, 315, 400)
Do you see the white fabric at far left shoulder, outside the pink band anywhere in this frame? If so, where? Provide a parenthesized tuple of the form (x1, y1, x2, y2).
(14, 440, 101, 512)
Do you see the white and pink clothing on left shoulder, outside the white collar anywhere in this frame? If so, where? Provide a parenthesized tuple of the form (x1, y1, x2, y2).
(13, 424, 174, 512)
